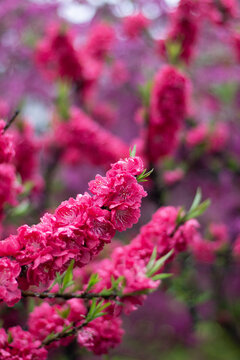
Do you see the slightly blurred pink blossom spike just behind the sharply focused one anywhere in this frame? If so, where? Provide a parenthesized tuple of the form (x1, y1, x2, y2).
(85, 207, 199, 313)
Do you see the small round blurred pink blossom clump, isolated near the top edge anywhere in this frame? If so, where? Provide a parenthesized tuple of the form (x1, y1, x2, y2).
(123, 13, 150, 39)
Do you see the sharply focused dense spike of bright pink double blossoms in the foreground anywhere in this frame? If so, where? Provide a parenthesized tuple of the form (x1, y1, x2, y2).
(0, 157, 147, 301)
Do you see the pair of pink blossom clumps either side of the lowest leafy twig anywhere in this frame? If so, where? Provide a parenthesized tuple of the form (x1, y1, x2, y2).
(28, 299, 123, 355)
